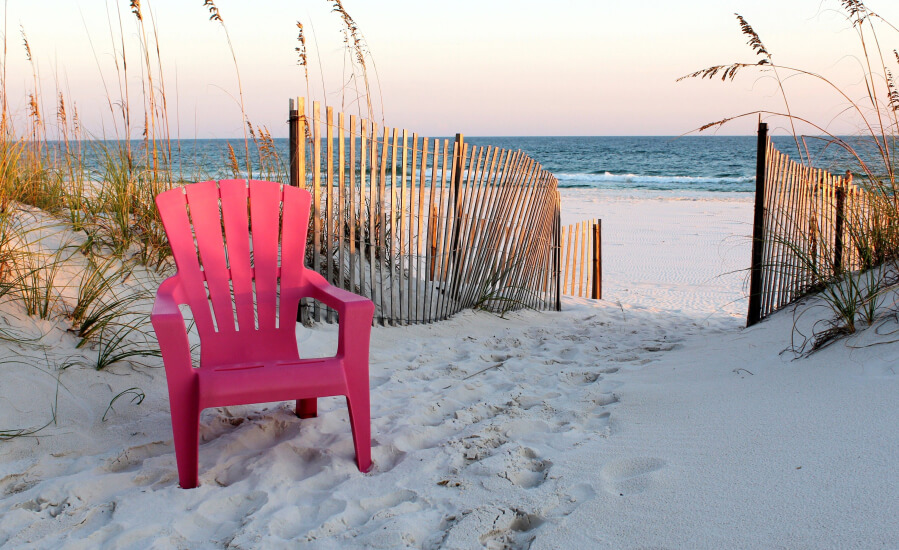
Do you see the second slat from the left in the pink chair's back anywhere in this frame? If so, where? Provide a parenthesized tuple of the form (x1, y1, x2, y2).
(186, 181, 235, 332)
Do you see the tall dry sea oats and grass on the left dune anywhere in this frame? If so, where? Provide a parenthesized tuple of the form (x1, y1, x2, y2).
(0, 0, 383, 378)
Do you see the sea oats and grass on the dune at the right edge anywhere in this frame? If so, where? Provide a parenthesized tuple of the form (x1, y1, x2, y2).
(679, 0, 899, 350)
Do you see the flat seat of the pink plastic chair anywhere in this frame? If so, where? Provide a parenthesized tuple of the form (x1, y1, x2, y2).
(197, 357, 347, 409)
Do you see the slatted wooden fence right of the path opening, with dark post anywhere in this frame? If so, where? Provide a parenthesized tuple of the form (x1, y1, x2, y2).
(747, 123, 875, 326)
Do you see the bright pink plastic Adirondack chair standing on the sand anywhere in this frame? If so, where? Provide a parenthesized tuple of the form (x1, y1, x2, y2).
(151, 180, 374, 489)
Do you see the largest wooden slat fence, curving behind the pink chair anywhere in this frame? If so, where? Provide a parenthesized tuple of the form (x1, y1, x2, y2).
(290, 98, 561, 325)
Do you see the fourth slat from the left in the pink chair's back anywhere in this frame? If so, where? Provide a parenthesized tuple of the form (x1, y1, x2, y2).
(250, 180, 284, 330)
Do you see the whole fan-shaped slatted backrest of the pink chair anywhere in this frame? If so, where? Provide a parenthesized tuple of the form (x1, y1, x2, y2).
(156, 180, 311, 366)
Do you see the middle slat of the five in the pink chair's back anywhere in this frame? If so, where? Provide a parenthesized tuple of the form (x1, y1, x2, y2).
(219, 180, 256, 331)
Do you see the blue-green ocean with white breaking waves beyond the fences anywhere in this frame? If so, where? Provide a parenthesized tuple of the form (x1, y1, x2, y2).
(81, 136, 851, 194)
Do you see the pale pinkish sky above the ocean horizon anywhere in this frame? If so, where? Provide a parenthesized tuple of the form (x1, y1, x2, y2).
(0, 0, 899, 138)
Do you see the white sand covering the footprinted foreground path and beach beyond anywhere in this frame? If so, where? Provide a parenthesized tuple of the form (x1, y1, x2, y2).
(0, 191, 899, 549)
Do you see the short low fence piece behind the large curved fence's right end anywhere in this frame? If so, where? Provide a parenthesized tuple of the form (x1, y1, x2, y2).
(562, 220, 602, 300)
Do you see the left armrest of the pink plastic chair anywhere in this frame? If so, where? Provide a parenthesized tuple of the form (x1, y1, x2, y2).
(150, 275, 195, 383)
